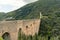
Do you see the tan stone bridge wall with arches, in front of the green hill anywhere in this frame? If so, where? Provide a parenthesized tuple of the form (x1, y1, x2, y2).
(0, 19, 40, 40)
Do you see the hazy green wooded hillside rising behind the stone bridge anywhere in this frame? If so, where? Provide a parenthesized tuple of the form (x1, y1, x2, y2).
(6, 0, 60, 19)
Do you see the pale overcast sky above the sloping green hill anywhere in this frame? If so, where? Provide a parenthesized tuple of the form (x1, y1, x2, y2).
(0, 0, 37, 12)
